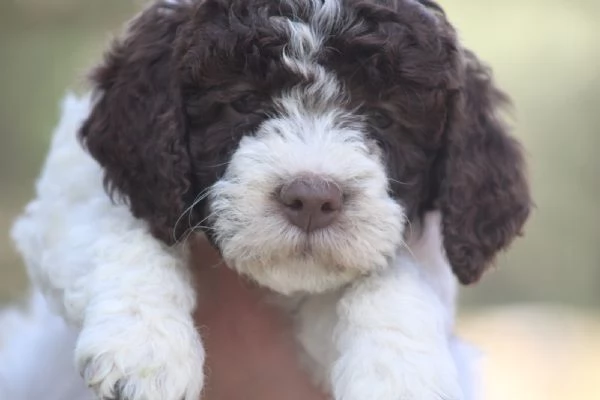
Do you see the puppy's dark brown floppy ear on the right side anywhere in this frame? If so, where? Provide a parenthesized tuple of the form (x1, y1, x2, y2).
(438, 50, 531, 284)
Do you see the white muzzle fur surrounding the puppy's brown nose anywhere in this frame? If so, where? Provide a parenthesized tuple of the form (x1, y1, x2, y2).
(210, 99, 404, 294)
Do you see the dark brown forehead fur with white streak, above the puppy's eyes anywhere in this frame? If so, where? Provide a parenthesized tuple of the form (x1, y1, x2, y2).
(179, 0, 457, 98)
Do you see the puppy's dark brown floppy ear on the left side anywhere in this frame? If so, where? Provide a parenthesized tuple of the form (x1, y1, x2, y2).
(80, 3, 191, 242)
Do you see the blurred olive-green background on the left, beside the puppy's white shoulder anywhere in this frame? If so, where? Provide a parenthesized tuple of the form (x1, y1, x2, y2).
(0, 0, 136, 303)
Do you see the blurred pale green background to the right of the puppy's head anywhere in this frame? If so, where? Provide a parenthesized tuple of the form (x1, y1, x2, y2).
(443, 0, 600, 307)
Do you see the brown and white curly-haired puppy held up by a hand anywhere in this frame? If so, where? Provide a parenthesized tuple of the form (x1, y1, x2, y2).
(13, 0, 531, 400)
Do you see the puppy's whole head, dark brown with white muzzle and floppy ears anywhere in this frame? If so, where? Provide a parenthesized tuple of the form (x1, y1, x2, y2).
(81, 0, 530, 293)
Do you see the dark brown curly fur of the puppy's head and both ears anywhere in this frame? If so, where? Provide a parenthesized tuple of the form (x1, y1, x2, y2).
(80, 0, 531, 284)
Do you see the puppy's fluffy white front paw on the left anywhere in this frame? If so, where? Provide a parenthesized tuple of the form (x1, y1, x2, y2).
(75, 317, 204, 400)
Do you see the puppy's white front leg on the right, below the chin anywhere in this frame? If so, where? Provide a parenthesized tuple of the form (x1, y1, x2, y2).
(332, 255, 463, 400)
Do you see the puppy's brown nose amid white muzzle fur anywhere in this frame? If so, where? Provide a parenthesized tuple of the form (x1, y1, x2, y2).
(279, 177, 343, 233)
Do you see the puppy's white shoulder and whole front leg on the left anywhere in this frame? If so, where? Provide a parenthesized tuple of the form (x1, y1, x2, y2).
(13, 96, 204, 400)
